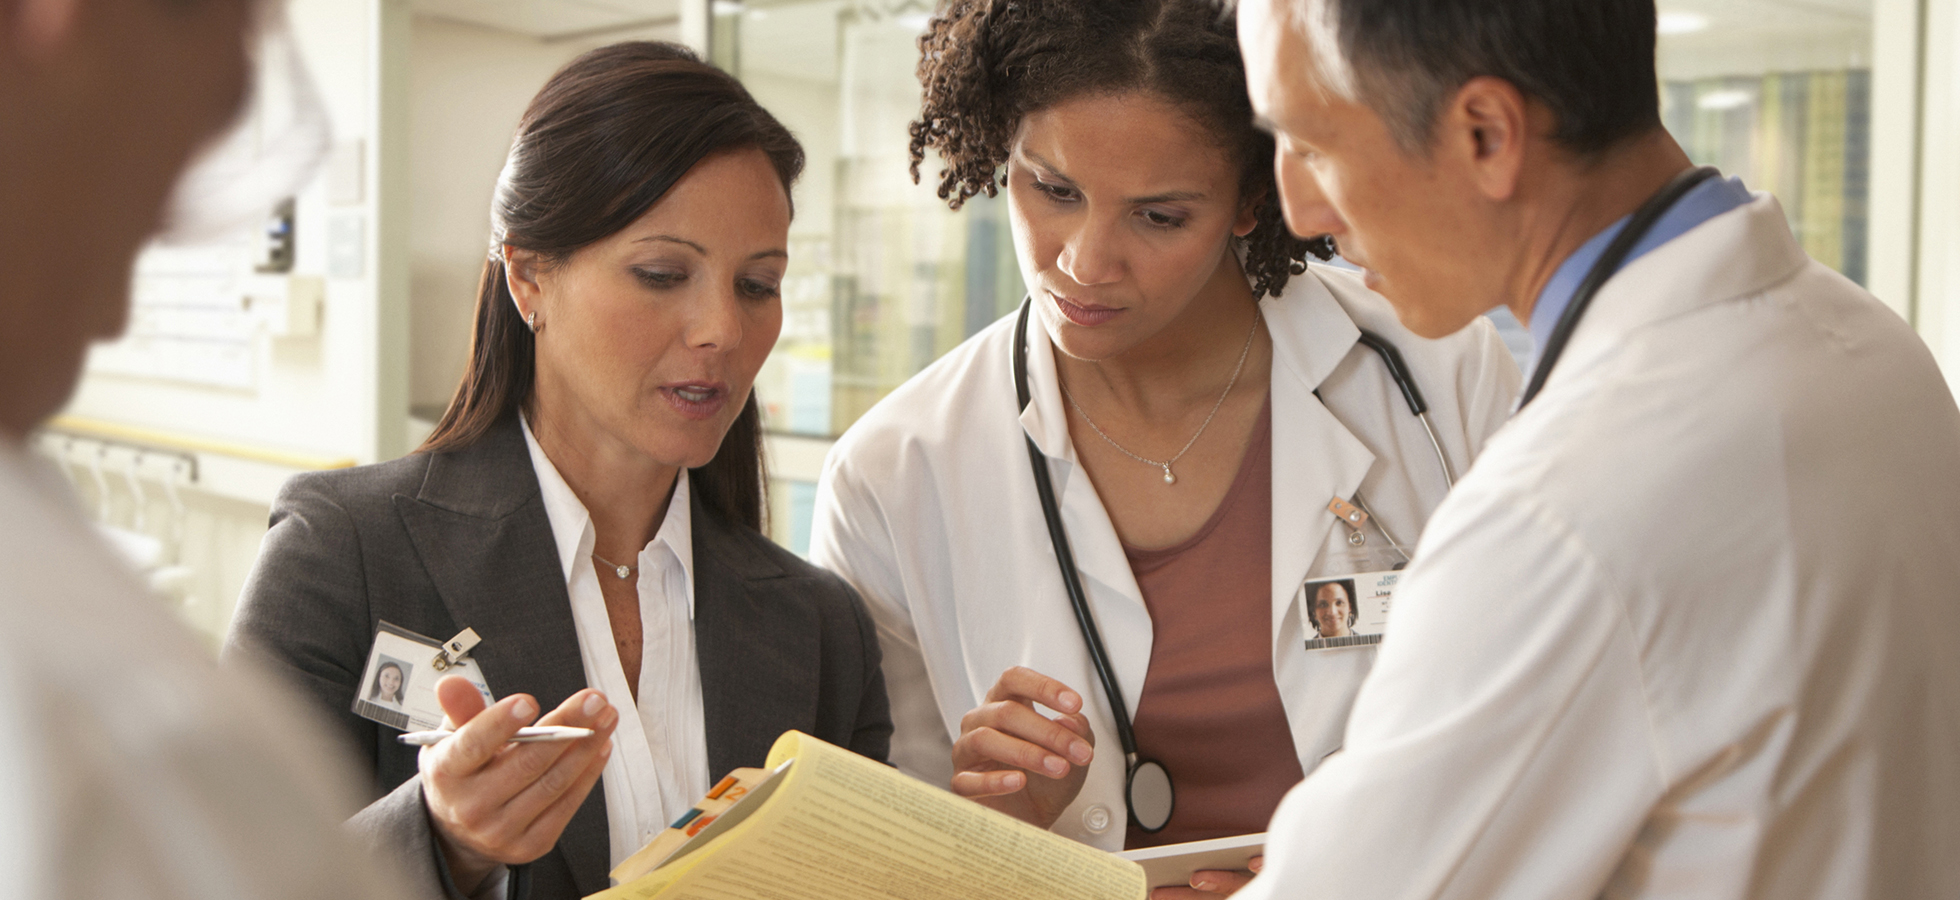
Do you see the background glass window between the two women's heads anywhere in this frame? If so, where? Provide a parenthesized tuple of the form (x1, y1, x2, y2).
(711, 0, 1023, 437)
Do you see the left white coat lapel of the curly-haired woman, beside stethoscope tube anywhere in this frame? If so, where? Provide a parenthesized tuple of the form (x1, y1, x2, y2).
(1009, 314, 1152, 716)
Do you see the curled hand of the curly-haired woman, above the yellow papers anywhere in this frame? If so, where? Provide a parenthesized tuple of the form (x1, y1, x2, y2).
(953, 667, 1096, 827)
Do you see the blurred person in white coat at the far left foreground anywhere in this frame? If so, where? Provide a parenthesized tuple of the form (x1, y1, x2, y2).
(0, 0, 411, 900)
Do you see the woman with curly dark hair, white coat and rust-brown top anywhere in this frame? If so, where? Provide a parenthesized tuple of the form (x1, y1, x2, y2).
(811, 0, 1517, 874)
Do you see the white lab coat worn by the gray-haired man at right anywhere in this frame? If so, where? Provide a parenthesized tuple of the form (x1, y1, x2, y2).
(1239, 194, 1960, 900)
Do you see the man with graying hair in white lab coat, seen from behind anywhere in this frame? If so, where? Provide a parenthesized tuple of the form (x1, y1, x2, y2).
(1239, 0, 1960, 900)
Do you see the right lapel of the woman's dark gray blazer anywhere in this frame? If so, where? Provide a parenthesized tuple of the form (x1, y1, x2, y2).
(690, 492, 821, 782)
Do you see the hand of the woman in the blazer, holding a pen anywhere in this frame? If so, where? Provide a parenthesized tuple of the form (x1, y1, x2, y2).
(419, 675, 619, 894)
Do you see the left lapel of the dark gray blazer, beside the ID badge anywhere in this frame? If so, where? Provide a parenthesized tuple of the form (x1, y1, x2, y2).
(394, 420, 612, 894)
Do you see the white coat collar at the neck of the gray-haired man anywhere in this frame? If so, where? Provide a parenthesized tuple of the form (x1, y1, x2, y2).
(1527, 192, 1809, 403)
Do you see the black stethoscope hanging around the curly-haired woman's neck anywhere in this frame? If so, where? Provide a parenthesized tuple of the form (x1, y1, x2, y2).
(1013, 298, 1456, 833)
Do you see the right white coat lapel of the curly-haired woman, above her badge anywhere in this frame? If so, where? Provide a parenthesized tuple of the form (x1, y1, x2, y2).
(1260, 284, 1374, 653)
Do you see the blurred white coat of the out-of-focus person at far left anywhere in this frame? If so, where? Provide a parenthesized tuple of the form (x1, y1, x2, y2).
(0, 437, 406, 900)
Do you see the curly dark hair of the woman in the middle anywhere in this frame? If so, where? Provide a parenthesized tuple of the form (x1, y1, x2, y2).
(911, 0, 1333, 296)
